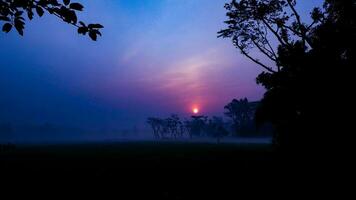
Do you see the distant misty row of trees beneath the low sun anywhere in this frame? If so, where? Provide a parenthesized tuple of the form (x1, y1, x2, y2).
(147, 98, 268, 142)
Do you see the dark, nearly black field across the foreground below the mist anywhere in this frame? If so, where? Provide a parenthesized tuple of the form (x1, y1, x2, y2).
(0, 142, 348, 199)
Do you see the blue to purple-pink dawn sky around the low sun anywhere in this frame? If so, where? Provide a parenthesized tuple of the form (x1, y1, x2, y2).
(0, 0, 320, 140)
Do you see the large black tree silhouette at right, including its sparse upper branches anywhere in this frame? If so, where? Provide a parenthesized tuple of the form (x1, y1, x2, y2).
(219, 0, 356, 149)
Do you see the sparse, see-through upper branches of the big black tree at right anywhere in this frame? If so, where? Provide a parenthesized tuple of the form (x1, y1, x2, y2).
(218, 0, 323, 73)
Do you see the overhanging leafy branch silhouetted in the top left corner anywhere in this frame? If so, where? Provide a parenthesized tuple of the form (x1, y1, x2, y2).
(0, 0, 104, 41)
